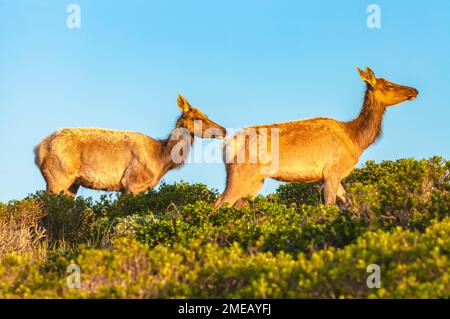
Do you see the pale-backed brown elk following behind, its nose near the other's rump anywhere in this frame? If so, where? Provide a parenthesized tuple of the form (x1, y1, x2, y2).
(35, 95, 226, 196)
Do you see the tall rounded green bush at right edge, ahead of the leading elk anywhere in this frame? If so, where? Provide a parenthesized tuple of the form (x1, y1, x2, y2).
(346, 157, 450, 229)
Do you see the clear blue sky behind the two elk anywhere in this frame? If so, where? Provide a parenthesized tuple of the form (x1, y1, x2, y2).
(0, 0, 450, 201)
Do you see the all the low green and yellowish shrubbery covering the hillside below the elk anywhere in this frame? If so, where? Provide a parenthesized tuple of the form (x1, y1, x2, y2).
(0, 157, 450, 298)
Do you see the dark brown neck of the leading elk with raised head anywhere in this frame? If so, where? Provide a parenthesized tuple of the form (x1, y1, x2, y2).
(346, 87, 386, 153)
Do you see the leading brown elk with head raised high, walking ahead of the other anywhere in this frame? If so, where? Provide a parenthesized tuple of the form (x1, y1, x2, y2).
(215, 68, 418, 208)
